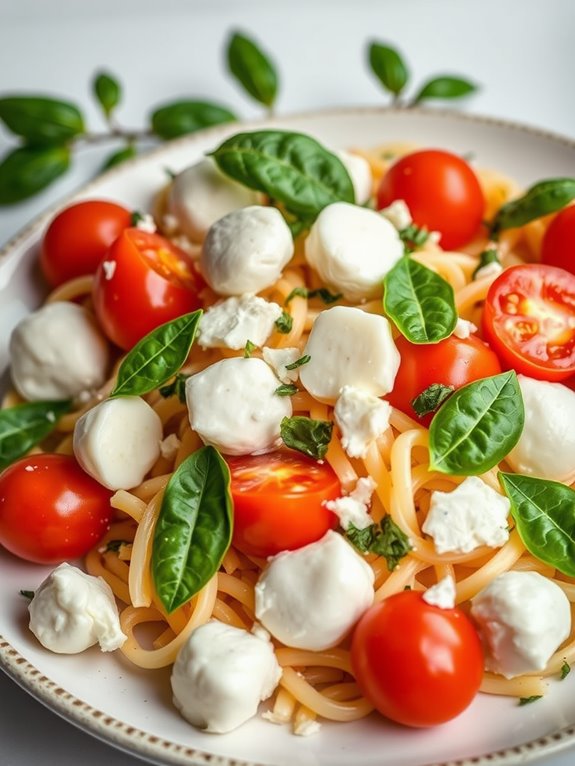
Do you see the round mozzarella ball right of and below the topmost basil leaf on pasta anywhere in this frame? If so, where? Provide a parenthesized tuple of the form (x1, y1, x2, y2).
(305, 202, 404, 301)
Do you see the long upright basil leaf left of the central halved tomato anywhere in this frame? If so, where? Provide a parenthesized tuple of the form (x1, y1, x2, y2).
(151, 447, 233, 613)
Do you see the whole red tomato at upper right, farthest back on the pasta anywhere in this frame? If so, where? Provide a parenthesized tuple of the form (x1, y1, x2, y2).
(377, 149, 485, 250)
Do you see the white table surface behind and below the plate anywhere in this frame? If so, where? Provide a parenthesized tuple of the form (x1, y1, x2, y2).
(0, 0, 575, 766)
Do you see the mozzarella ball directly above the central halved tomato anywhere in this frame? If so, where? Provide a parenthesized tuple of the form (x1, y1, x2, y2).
(186, 357, 292, 455)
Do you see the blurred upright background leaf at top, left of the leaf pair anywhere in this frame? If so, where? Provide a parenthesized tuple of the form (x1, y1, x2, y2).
(227, 32, 278, 107)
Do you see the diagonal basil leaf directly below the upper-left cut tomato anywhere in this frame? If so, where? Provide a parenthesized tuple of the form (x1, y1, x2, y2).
(110, 310, 202, 397)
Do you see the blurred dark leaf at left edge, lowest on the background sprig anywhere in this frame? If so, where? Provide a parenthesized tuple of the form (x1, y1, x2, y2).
(0, 146, 70, 205)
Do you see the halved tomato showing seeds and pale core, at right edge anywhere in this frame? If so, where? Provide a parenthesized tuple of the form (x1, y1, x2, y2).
(483, 263, 575, 381)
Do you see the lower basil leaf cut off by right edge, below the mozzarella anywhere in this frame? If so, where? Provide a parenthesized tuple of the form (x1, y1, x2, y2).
(499, 473, 575, 577)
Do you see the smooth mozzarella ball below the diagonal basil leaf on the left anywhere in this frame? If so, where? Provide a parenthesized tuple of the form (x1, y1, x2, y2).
(74, 396, 162, 489)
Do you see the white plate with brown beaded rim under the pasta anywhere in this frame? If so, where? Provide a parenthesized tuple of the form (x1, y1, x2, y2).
(0, 110, 575, 766)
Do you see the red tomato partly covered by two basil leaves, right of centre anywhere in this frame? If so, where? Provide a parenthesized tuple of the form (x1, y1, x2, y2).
(385, 335, 501, 426)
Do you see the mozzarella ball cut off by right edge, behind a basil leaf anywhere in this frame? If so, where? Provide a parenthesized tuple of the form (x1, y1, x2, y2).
(507, 375, 575, 484)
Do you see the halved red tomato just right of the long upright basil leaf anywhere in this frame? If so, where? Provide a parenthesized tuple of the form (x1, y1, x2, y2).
(226, 452, 341, 556)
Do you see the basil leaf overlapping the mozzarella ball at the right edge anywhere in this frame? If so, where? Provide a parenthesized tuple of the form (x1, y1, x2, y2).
(429, 370, 525, 476)
